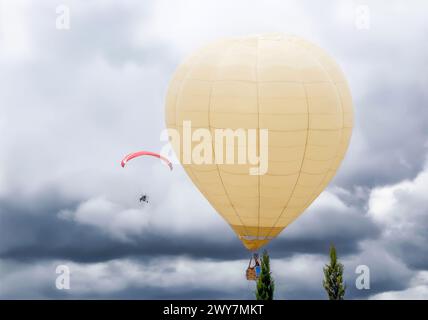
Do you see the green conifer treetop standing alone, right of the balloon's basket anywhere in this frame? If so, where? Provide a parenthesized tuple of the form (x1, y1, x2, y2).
(323, 245, 346, 300)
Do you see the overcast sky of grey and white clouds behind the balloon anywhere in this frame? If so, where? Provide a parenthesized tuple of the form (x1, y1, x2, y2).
(0, 0, 428, 299)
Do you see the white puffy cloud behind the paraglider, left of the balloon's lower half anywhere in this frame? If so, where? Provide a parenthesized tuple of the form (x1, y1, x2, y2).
(59, 164, 234, 242)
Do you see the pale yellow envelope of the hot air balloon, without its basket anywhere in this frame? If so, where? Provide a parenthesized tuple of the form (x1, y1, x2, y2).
(166, 34, 353, 250)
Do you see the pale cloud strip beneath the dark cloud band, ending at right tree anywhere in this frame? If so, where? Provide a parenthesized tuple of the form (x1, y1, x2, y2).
(0, 255, 323, 299)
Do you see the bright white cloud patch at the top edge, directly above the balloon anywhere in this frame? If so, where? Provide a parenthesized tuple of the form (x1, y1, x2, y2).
(137, 0, 316, 55)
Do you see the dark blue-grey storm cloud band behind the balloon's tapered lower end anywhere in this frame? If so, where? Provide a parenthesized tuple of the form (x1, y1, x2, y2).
(0, 186, 379, 262)
